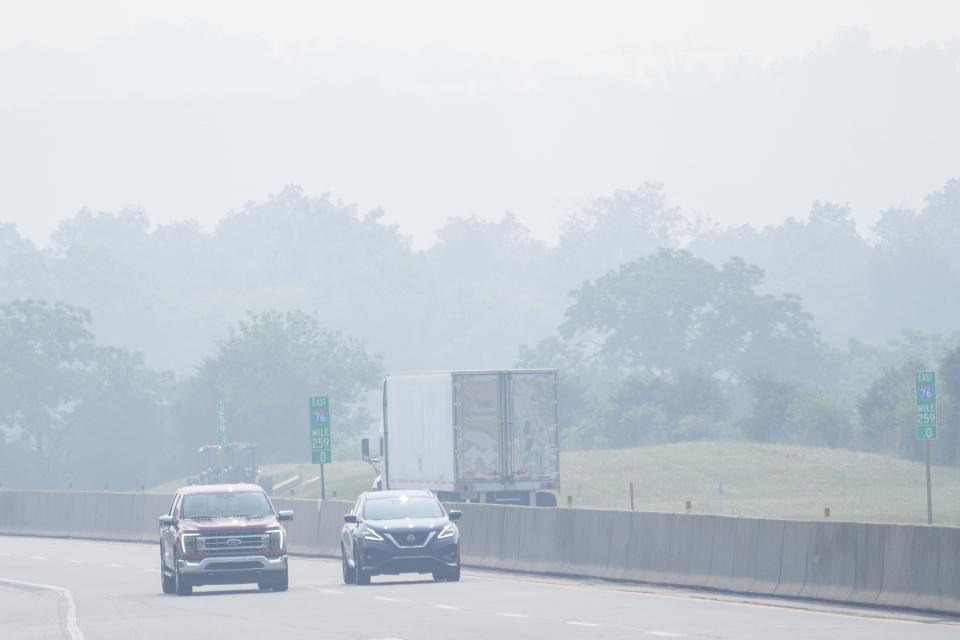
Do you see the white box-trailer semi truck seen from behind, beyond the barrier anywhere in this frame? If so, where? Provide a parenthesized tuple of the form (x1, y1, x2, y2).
(362, 369, 560, 506)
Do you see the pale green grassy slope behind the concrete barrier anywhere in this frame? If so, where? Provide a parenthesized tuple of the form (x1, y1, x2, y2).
(153, 442, 960, 525)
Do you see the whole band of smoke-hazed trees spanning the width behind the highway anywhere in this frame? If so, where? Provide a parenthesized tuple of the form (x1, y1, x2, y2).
(0, 180, 960, 487)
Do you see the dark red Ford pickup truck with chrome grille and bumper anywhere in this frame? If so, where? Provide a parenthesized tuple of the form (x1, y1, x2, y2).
(160, 484, 293, 595)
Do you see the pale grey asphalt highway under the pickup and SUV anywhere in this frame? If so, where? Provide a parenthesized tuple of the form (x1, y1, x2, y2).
(0, 536, 960, 640)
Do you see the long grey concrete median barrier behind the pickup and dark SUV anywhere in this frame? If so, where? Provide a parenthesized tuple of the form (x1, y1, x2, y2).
(0, 490, 960, 614)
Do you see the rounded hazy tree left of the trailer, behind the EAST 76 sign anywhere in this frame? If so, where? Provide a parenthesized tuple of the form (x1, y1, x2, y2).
(177, 311, 383, 461)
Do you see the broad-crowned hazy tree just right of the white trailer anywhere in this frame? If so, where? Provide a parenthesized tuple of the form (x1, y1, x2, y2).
(560, 249, 821, 379)
